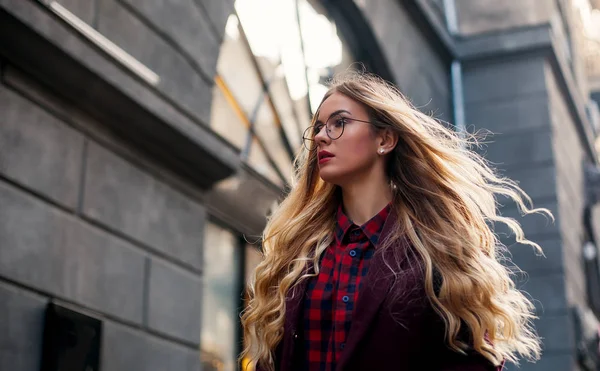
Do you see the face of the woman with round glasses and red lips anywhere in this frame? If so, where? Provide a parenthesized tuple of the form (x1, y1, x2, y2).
(314, 92, 380, 186)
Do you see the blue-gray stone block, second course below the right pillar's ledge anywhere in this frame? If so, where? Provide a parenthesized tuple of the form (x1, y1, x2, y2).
(465, 93, 550, 134)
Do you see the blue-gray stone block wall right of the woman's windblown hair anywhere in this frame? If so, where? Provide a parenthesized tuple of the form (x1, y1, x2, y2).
(464, 55, 584, 371)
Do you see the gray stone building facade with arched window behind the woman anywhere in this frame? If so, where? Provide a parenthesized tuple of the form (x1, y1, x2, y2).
(0, 0, 600, 371)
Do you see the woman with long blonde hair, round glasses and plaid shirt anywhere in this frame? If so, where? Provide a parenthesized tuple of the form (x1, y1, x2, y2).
(242, 73, 547, 371)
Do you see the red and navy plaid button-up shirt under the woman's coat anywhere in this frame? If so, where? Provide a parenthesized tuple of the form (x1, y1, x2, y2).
(304, 205, 390, 371)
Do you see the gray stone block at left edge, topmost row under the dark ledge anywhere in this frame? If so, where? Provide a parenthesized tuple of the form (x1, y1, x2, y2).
(0, 85, 84, 208)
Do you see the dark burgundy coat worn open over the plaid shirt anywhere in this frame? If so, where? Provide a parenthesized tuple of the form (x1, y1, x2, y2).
(258, 213, 501, 371)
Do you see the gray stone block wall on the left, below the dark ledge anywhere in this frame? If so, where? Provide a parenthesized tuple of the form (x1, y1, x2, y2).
(0, 62, 206, 371)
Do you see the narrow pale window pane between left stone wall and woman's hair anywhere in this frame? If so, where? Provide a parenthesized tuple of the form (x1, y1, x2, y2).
(200, 223, 242, 371)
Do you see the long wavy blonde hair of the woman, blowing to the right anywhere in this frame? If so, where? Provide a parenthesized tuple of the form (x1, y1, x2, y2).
(240, 72, 552, 370)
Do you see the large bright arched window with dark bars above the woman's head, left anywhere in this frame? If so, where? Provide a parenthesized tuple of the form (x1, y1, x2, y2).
(211, 0, 354, 187)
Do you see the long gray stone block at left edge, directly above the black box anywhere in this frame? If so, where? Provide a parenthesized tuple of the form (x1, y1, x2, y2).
(0, 184, 145, 323)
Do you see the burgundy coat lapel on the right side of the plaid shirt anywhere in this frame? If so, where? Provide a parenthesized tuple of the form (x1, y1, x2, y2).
(336, 212, 406, 370)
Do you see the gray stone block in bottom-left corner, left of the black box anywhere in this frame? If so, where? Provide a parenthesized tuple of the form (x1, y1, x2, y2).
(0, 284, 47, 371)
